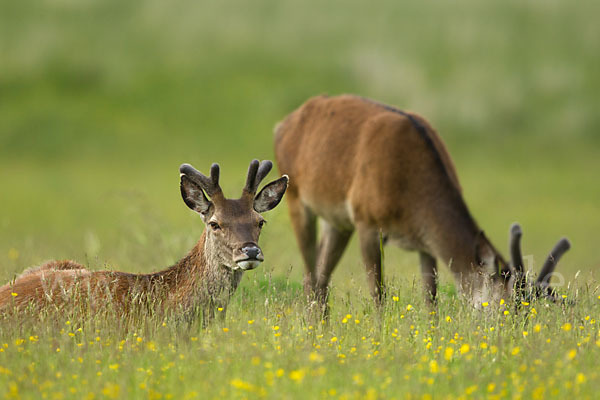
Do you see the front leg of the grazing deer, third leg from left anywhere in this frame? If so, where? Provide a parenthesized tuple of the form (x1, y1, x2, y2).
(358, 226, 383, 306)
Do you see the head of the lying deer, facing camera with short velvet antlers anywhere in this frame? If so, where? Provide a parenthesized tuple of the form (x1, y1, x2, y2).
(179, 160, 288, 270)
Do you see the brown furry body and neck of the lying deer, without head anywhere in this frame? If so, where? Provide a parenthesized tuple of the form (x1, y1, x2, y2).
(0, 233, 242, 315)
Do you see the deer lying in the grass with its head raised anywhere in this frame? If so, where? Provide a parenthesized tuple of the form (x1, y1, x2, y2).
(0, 160, 288, 319)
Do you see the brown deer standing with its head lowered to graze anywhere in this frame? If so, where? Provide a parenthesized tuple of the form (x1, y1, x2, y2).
(275, 95, 569, 304)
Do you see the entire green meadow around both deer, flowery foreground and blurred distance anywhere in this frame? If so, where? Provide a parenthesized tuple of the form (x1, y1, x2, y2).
(0, 0, 600, 399)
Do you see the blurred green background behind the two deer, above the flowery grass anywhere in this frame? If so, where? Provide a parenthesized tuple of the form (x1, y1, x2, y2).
(0, 0, 600, 287)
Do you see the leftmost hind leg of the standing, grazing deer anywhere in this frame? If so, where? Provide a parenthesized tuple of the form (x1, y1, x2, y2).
(287, 192, 317, 296)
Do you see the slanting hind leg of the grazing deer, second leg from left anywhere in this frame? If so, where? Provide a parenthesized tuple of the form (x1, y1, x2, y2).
(316, 221, 353, 305)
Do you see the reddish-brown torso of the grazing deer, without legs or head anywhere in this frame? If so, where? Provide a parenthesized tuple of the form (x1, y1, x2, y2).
(275, 95, 478, 255)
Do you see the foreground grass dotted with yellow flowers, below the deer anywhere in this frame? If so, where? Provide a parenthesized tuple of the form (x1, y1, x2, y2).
(0, 272, 600, 398)
